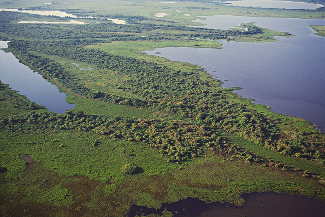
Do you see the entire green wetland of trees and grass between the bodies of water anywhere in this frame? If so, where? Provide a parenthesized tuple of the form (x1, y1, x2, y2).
(0, 0, 325, 216)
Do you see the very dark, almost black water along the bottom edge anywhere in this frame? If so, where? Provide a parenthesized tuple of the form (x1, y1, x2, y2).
(128, 192, 325, 217)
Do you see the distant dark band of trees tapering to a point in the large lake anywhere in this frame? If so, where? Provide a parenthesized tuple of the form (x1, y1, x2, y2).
(0, 11, 263, 42)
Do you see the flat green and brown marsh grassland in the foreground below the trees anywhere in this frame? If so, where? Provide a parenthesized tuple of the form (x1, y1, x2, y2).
(1, 122, 324, 216)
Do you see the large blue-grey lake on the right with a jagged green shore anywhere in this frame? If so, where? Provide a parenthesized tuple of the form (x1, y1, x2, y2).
(147, 15, 325, 131)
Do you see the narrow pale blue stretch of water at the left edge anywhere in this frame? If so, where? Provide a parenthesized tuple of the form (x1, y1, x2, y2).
(0, 41, 74, 113)
